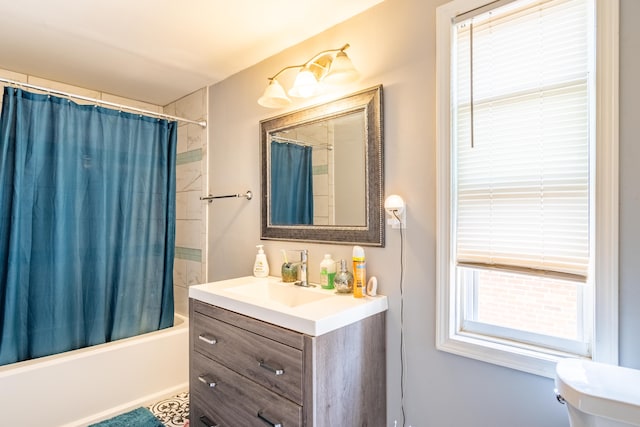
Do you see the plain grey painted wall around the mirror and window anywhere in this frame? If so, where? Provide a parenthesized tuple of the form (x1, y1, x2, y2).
(208, 0, 640, 427)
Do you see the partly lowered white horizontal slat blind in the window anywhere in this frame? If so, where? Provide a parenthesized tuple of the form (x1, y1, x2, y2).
(452, 0, 592, 278)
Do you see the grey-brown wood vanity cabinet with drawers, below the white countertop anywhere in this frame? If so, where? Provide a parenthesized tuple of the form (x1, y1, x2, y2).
(189, 299, 386, 427)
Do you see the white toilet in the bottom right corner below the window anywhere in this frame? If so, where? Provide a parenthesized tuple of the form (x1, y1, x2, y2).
(556, 359, 640, 427)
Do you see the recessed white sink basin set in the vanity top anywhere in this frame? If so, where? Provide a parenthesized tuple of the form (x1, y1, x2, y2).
(228, 281, 332, 307)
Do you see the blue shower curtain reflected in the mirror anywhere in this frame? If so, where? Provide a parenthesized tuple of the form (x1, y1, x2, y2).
(270, 141, 313, 225)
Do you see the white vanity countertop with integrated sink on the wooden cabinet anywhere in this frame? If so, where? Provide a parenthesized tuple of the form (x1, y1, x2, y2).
(189, 276, 389, 336)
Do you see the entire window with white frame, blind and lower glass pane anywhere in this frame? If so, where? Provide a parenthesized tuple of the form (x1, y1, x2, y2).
(437, 0, 618, 377)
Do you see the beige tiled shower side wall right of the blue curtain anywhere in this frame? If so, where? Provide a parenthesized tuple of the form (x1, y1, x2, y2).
(164, 88, 208, 315)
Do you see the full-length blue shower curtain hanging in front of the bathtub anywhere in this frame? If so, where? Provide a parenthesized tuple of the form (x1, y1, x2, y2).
(0, 88, 177, 365)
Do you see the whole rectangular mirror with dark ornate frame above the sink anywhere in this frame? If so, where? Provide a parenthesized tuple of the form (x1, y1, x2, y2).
(260, 85, 384, 246)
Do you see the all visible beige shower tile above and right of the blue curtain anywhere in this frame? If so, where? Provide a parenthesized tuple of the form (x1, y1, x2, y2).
(0, 69, 208, 315)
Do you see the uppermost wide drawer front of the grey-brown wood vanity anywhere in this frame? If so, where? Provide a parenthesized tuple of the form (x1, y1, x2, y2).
(190, 313, 303, 404)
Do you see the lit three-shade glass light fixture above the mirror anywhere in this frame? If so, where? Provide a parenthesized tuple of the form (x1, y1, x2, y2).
(258, 43, 360, 108)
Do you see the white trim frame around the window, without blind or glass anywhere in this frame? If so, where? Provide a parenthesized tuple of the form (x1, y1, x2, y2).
(436, 0, 619, 378)
